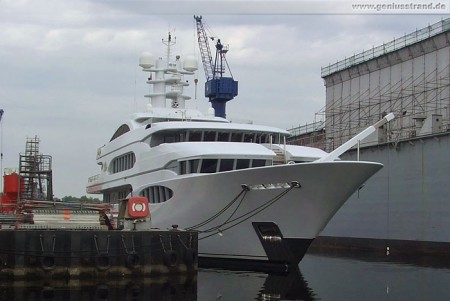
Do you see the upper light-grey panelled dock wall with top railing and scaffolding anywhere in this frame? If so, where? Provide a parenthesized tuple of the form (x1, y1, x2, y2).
(289, 19, 450, 151)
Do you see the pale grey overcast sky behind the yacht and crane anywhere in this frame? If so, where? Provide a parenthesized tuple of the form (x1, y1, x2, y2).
(0, 0, 450, 198)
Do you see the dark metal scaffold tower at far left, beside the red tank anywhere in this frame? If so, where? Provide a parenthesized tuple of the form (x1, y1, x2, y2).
(19, 136, 53, 201)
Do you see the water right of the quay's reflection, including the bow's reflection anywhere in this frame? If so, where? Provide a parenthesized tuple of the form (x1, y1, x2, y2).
(197, 254, 450, 301)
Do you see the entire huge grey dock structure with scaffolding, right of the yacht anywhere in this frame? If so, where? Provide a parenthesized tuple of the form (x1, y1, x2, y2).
(290, 19, 450, 255)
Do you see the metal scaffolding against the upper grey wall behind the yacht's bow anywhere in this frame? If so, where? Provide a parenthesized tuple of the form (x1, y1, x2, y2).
(320, 65, 450, 151)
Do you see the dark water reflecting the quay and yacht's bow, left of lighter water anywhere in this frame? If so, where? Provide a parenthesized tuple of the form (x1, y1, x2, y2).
(0, 270, 314, 301)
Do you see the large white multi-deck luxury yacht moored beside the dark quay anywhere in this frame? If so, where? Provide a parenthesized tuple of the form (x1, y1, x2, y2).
(87, 32, 382, 265)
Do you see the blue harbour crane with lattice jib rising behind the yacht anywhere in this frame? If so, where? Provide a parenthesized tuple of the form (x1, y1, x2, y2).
(194, 16, 238, 118)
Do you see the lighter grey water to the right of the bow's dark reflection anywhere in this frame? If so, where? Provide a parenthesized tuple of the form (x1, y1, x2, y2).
(300, 254, 450, 301)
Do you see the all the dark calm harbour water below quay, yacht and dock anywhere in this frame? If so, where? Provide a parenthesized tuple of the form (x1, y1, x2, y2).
(0, 255, 450, 301)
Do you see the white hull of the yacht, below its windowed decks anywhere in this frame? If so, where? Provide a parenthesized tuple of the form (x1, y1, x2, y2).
(128, 161, 382, 260)
